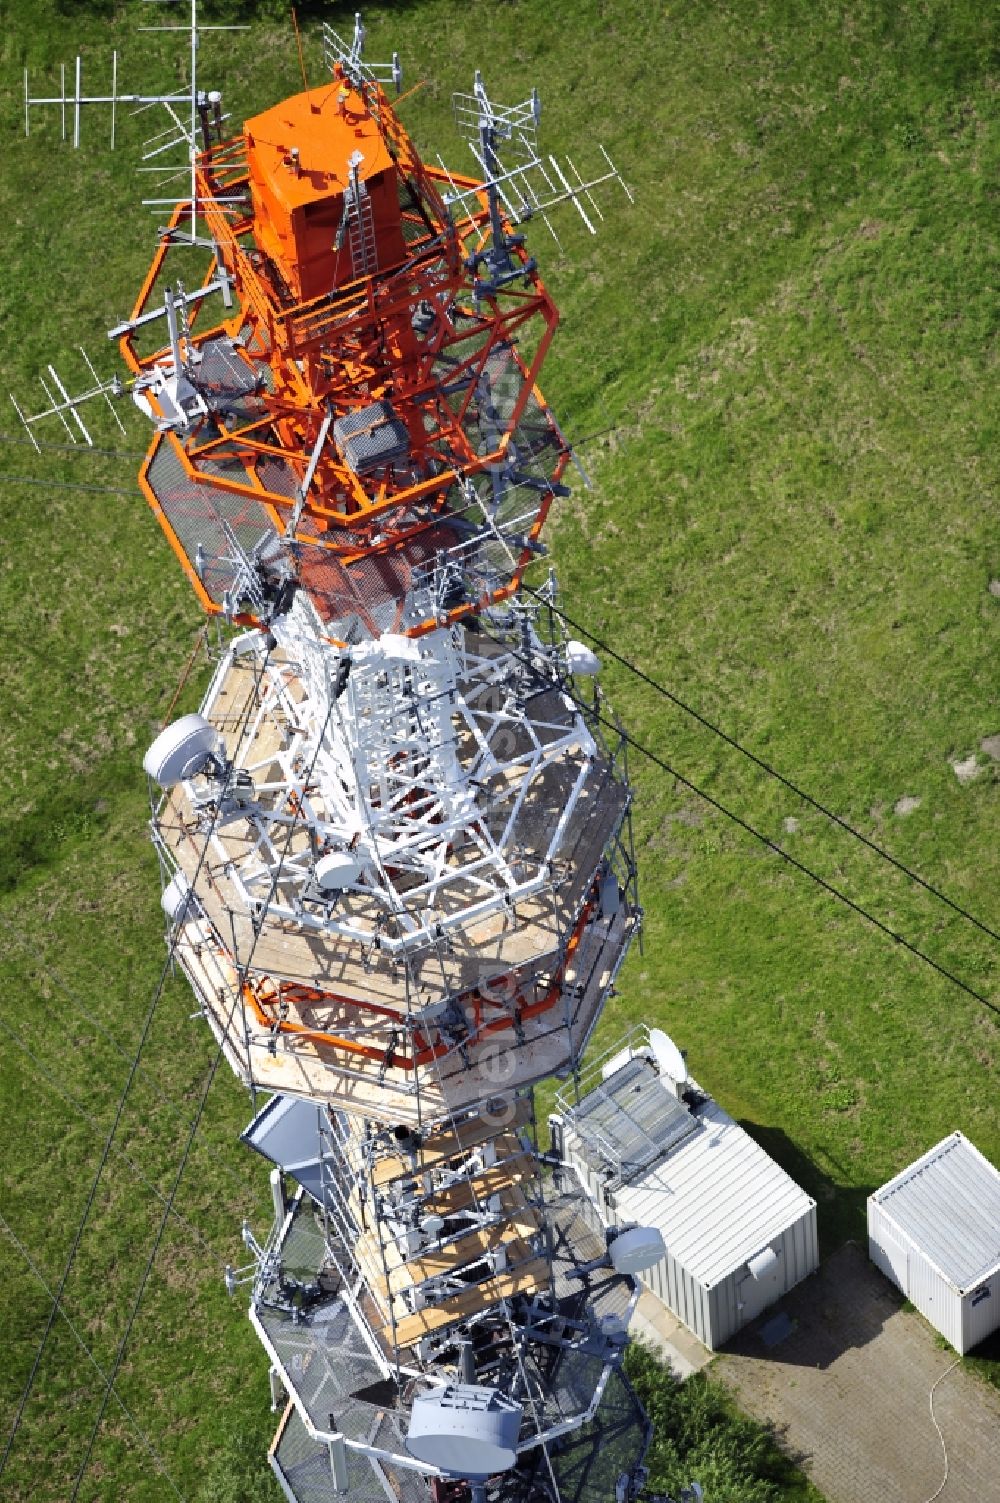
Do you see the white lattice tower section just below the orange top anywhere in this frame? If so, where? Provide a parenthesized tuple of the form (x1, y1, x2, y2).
(186, 594, 595, 953)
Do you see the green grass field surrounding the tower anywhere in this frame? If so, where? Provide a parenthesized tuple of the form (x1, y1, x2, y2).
(0, 0, 1000, 1503)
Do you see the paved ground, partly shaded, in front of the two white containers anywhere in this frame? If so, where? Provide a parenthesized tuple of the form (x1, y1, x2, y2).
(713, 1243, 1000, 1503)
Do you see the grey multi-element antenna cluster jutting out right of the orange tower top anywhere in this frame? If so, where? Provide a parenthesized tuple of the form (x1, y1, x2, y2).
(445, 69, 635, 292)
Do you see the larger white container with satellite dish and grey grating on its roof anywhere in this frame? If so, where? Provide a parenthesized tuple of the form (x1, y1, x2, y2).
(550, 1036, 820, 1350)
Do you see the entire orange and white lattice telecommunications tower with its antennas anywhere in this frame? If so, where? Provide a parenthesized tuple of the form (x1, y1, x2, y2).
(3, 11, 700, 1503)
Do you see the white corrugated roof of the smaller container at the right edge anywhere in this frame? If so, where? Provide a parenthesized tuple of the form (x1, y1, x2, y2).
(872, 1132, 1000, 1291)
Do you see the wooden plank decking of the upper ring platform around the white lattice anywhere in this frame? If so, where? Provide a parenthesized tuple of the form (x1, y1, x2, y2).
(158, 660, 627, 1033)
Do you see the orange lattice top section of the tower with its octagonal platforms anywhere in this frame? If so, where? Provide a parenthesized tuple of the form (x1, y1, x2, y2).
(120, 63, 568, 636)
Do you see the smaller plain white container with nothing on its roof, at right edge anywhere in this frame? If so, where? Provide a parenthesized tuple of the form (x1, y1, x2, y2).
(868, 1132, 1000, 1353)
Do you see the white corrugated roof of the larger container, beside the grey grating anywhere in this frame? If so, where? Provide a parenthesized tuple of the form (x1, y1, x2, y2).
(589, 1100, 815, 1288)
